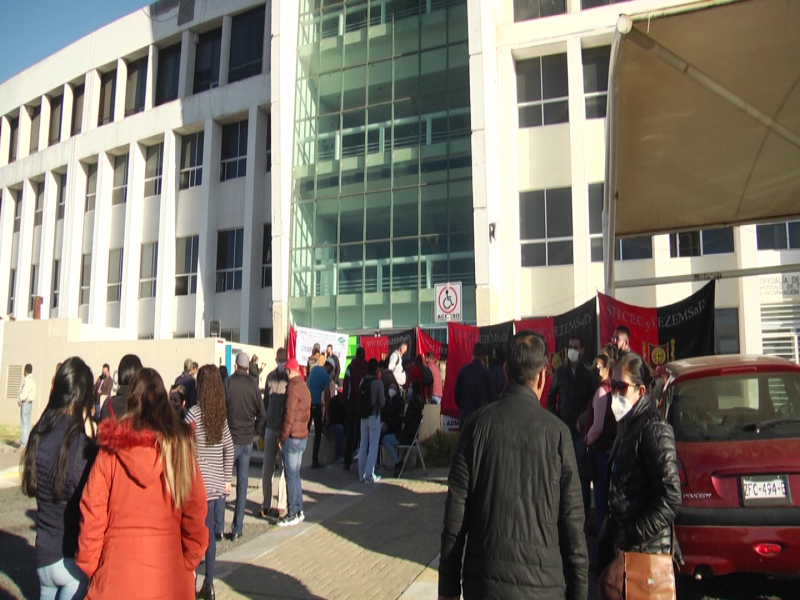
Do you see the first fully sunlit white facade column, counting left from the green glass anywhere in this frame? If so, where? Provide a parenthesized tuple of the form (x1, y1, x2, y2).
(153, 129, 178, 340)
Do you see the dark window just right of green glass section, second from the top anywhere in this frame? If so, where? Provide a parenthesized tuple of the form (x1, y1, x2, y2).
(517, 54, 569, 128)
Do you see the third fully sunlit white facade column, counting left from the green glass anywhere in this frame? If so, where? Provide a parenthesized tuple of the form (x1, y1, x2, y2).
(89, 152, 114, 327)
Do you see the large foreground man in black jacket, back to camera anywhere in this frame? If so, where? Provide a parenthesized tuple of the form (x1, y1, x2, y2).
(439, 331, 589, 600)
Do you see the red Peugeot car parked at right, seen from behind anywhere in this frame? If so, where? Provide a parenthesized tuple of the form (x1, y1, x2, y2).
(655, 356, 800, 579)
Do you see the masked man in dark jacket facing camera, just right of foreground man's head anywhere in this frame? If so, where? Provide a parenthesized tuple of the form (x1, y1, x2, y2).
(547, 336, 596, 524)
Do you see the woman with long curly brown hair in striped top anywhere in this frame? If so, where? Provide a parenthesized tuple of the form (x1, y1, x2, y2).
(186, 365, 234, 600)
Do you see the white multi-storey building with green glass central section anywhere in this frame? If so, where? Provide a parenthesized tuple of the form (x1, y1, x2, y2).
(0, 0, 800, 360)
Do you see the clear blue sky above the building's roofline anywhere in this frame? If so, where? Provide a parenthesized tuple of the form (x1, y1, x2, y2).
(0, 0, 153, 82)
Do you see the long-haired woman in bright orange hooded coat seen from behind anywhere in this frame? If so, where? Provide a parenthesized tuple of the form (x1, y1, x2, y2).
(76, 369, 208, 600)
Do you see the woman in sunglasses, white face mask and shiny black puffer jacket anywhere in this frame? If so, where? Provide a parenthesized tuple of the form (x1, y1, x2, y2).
(598, 353, 681, 589)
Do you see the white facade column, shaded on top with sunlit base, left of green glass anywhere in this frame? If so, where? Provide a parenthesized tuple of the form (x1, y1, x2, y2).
(194, 118, 225, 337)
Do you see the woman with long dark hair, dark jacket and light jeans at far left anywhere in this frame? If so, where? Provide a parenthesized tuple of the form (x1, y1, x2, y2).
(22, 357, 95, 600)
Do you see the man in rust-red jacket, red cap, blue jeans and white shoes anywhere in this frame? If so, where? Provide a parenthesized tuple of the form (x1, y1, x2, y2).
(278, 358, 311, 527)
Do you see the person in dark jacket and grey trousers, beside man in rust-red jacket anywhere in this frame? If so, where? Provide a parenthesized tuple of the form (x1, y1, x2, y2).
(260, 348, 289, 519)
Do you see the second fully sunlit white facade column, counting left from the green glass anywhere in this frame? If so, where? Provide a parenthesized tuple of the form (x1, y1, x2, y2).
(119, 142, 145, 336)
